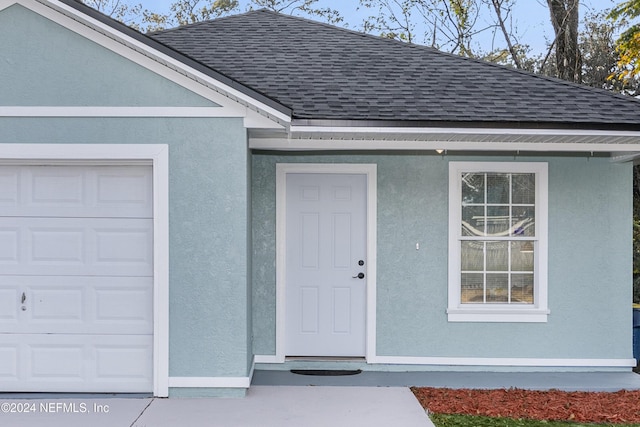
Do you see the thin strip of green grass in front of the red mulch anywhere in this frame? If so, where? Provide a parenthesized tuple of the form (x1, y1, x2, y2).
(429, 414, 640, 427)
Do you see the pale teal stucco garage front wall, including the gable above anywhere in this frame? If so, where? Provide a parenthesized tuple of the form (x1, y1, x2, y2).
(0, 6, 252, 395)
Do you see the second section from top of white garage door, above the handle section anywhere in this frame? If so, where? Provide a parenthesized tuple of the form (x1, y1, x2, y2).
(0, 218, 153, 276)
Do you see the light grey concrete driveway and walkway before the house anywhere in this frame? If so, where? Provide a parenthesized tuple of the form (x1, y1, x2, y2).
(0, 386, 433, 427)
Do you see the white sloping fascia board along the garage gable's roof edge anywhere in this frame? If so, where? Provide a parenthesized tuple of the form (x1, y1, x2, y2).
(12, 0, 291, 129)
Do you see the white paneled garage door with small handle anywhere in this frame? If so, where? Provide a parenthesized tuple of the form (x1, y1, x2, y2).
(0, 165, 153, 392)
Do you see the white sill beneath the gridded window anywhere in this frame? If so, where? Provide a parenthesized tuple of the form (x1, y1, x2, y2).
(447, 307, 549, 323)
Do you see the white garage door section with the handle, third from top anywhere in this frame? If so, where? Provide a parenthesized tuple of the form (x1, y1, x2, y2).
(0, 276, 153, 334)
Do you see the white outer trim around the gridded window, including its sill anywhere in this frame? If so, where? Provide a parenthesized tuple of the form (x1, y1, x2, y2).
(447, 162, 549, 322)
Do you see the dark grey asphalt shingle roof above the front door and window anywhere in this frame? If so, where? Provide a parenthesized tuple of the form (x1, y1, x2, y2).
(152, 10, 640, 128)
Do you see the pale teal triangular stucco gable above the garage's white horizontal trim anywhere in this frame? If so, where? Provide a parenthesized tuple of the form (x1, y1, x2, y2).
(0, 5, 216, 107)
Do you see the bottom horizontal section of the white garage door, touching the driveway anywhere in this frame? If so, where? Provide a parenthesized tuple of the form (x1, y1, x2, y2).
(0, 334, 153, 393)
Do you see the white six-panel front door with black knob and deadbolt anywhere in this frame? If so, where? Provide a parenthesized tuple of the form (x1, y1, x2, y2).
(285, 173, 367, 357)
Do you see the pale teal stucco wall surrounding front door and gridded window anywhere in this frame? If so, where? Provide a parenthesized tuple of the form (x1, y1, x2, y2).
(252, 153, 632, 369)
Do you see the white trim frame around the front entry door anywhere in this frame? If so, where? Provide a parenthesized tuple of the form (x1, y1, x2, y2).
(271, 163, 378, 363)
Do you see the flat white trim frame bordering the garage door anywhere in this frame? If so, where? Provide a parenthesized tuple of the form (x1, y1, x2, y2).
(0, 144, 169, 397)
